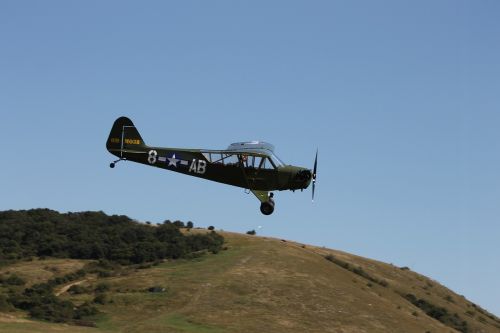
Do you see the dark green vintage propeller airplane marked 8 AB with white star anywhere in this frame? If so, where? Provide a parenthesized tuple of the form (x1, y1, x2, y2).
(106, 117, 318, 215)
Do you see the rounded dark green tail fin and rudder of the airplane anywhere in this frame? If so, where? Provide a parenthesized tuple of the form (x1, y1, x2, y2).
(106, 117, 146, 156)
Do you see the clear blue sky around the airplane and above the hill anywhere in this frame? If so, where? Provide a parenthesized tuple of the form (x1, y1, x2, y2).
(0, 0, 500, 315)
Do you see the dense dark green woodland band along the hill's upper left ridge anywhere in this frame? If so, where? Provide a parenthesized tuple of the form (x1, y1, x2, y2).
(0, 209, 223, 264)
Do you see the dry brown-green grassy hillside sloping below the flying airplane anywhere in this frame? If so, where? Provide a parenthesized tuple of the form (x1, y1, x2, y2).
(0, 230, 500, 333)
